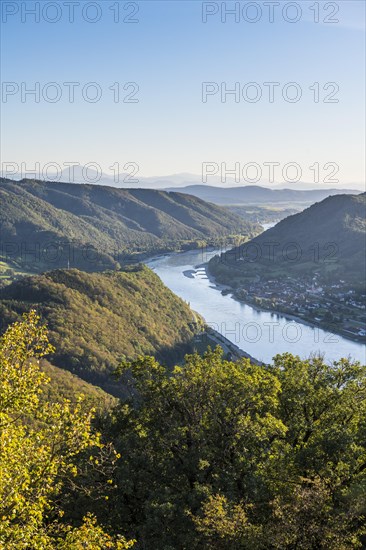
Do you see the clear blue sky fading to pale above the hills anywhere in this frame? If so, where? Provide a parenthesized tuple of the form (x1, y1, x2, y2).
(1, 0, 365, 187)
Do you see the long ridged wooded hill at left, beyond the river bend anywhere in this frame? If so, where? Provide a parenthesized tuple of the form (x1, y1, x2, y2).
(0, 179, 260, 272)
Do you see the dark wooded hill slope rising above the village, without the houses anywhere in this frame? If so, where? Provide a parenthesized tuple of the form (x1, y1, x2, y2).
(210, 193, 366, 285)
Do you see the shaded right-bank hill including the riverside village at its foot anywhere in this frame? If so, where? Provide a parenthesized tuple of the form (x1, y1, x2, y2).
(209, 193, 366, 341)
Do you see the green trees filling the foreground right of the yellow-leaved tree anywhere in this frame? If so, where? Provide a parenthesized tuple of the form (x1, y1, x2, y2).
(111, 348, 366, 550)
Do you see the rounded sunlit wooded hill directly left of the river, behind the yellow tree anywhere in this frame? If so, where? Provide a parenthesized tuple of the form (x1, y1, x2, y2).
(0, 266, 200, 395)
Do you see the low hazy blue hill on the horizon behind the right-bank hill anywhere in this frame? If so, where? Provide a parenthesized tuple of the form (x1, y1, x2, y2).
(166, 185, 357, 205)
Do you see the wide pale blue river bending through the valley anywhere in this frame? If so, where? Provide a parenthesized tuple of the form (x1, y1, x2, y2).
(147, 244, 366, 364)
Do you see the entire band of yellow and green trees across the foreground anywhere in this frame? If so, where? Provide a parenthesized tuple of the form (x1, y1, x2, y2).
(0, 311, 366, 550)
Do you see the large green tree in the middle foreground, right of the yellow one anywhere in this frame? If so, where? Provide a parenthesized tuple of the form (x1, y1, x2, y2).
(114, 348, 286, 549)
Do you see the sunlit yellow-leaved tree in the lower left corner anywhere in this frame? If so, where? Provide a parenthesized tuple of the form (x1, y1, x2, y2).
(0, 311, 132, 550)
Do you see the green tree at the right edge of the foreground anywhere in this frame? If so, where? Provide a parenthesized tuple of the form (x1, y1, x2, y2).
(268, 354, 366, 549)
